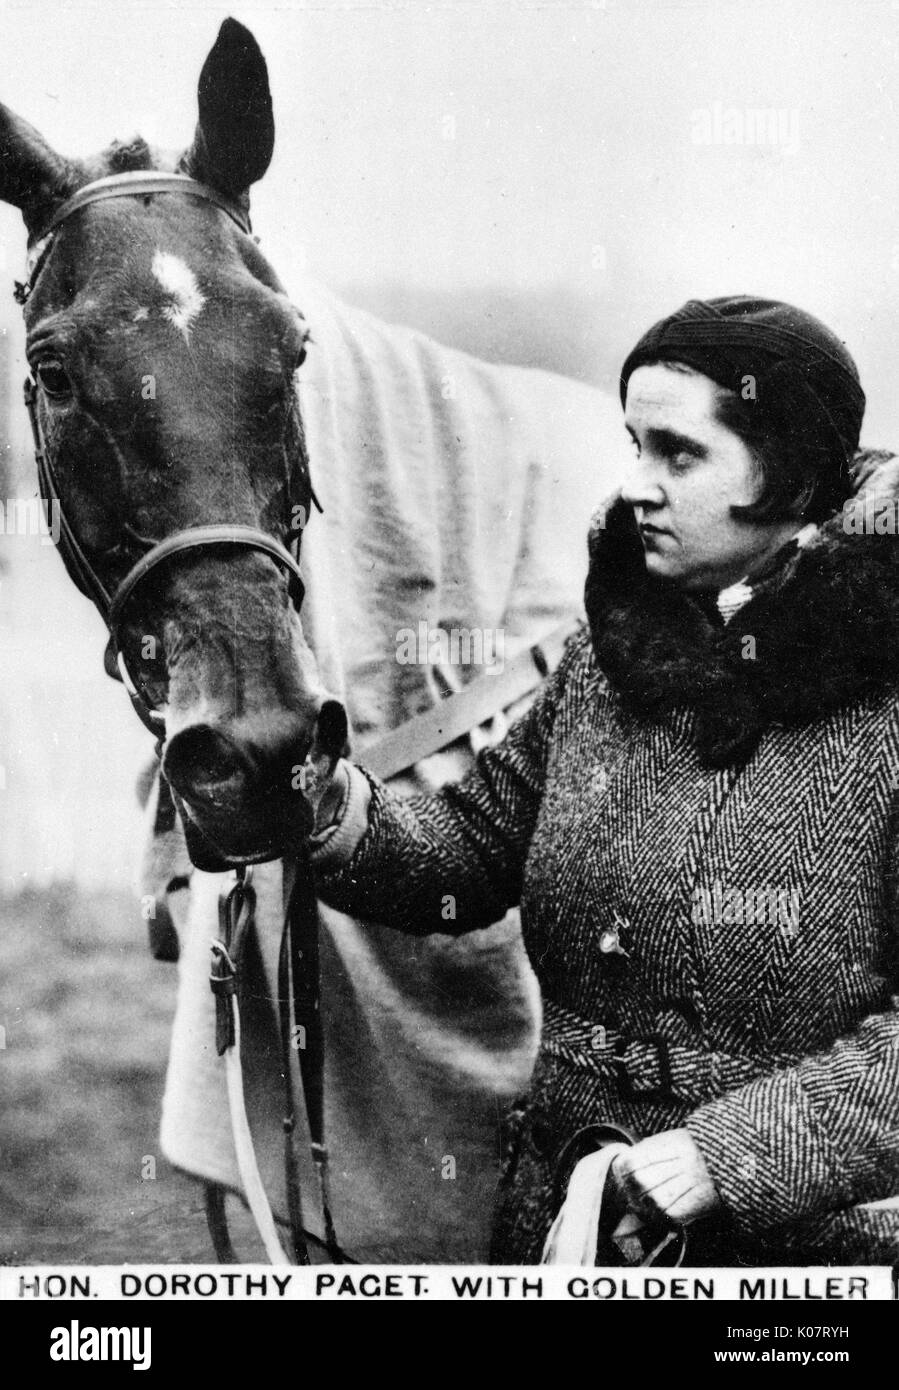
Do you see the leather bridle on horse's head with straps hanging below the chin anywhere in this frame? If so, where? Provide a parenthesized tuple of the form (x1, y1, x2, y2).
(15, 171, 347, 1264)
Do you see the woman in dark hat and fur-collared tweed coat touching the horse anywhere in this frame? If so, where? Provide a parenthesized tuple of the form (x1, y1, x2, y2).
(307, 296, 899, 1264)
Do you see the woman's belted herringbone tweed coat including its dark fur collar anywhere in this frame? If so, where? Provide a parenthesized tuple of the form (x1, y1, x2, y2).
(318, 461, 899, 1265)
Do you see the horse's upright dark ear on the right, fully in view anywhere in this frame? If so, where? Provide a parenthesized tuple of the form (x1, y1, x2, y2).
(182, 19, 275, 197)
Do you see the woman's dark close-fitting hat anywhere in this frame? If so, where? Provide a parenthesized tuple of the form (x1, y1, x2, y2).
(621, 295, 864, 514)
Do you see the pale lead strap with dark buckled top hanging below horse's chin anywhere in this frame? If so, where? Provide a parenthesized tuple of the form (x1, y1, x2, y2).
(210, 869, 290, 1265)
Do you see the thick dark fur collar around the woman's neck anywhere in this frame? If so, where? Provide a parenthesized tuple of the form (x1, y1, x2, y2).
(586, 455, 899, 767)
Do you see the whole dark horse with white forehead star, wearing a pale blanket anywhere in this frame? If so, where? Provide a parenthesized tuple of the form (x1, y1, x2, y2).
(0, 21, 622, 1261)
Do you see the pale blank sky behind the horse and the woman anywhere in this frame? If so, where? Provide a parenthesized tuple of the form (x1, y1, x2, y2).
(0, 0, 899, 894)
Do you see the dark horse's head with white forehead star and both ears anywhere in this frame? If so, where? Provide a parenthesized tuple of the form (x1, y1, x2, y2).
(0, 19, 346, 867)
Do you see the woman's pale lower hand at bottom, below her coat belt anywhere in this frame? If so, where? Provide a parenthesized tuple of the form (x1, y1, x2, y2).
(611, 1129, 721, 1226)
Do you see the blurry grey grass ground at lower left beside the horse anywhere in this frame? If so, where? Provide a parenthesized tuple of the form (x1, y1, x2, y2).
(0, 888, 232, 1265)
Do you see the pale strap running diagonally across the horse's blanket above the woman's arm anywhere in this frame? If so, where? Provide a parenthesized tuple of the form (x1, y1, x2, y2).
(358, 620, 572, 781)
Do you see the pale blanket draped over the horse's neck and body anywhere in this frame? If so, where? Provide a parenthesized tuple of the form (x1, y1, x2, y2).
(143, 271, 625, 1264)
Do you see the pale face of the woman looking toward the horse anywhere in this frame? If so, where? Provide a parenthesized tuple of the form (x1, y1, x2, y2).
(622, 363, 799, 591)
